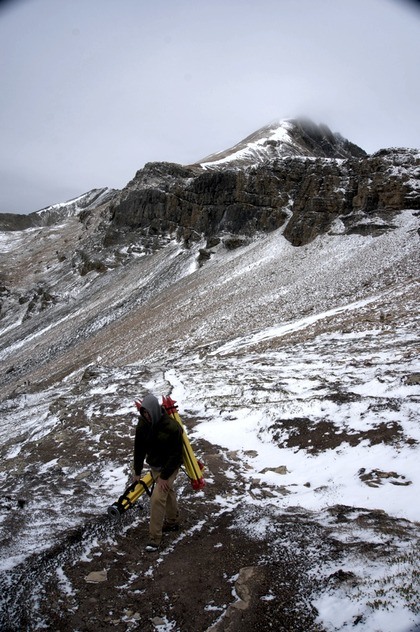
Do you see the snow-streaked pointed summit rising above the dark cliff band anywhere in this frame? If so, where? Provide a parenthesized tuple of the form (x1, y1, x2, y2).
(197, 119, 366, 169)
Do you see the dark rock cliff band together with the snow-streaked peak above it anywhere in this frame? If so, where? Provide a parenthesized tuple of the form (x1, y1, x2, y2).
(105, 122, 420, 246)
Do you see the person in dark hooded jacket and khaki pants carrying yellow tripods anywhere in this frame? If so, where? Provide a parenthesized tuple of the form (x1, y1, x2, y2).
(134, 393, 182, 551)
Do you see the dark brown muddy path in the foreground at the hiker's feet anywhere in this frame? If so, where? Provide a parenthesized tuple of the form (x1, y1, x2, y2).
(2, 446, 331, 632)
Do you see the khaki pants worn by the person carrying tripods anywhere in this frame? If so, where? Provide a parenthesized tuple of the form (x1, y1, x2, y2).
(149, 468, 179, 544)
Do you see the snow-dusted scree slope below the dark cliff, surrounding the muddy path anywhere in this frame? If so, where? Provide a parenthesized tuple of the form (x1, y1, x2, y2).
(0, 201, 420, 632)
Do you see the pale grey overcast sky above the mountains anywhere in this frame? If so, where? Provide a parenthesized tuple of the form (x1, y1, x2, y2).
(0, 0, 420, 213)
